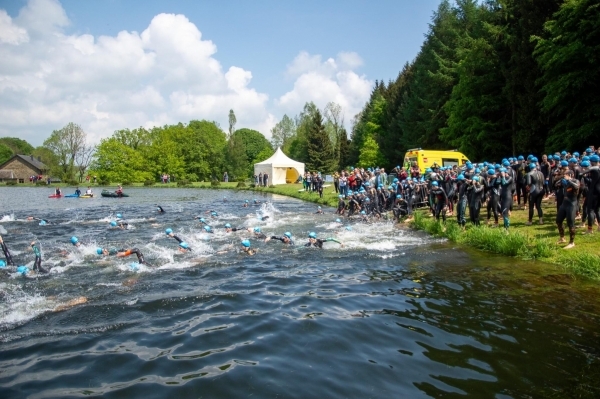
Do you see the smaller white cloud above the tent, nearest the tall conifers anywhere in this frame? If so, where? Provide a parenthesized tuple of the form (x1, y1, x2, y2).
(275, 51, 373, 123)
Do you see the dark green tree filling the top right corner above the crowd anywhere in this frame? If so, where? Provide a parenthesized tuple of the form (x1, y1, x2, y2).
(534, 0, 600, 149)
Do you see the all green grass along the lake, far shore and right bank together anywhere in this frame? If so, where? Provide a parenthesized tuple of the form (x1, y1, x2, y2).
(7, 182, 600, 280)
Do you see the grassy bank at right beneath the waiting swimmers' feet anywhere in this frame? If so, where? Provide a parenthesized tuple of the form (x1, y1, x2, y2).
(411, 201, 600, 280)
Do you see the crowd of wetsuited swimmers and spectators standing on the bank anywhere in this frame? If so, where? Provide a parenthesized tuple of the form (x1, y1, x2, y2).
(318, 147, 600, 248)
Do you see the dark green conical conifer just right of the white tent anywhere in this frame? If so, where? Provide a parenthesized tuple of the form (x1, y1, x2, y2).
(306, 109, 335, 173)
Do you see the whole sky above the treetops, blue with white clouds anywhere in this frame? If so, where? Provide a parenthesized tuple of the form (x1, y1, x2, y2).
(0, 0, 439, 145)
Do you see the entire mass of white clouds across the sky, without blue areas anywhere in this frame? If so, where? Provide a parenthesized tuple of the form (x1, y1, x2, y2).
(0, 0, 372, 145)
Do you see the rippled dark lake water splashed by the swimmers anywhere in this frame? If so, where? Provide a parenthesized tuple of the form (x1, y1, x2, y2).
(0, 188, 600, 399)
